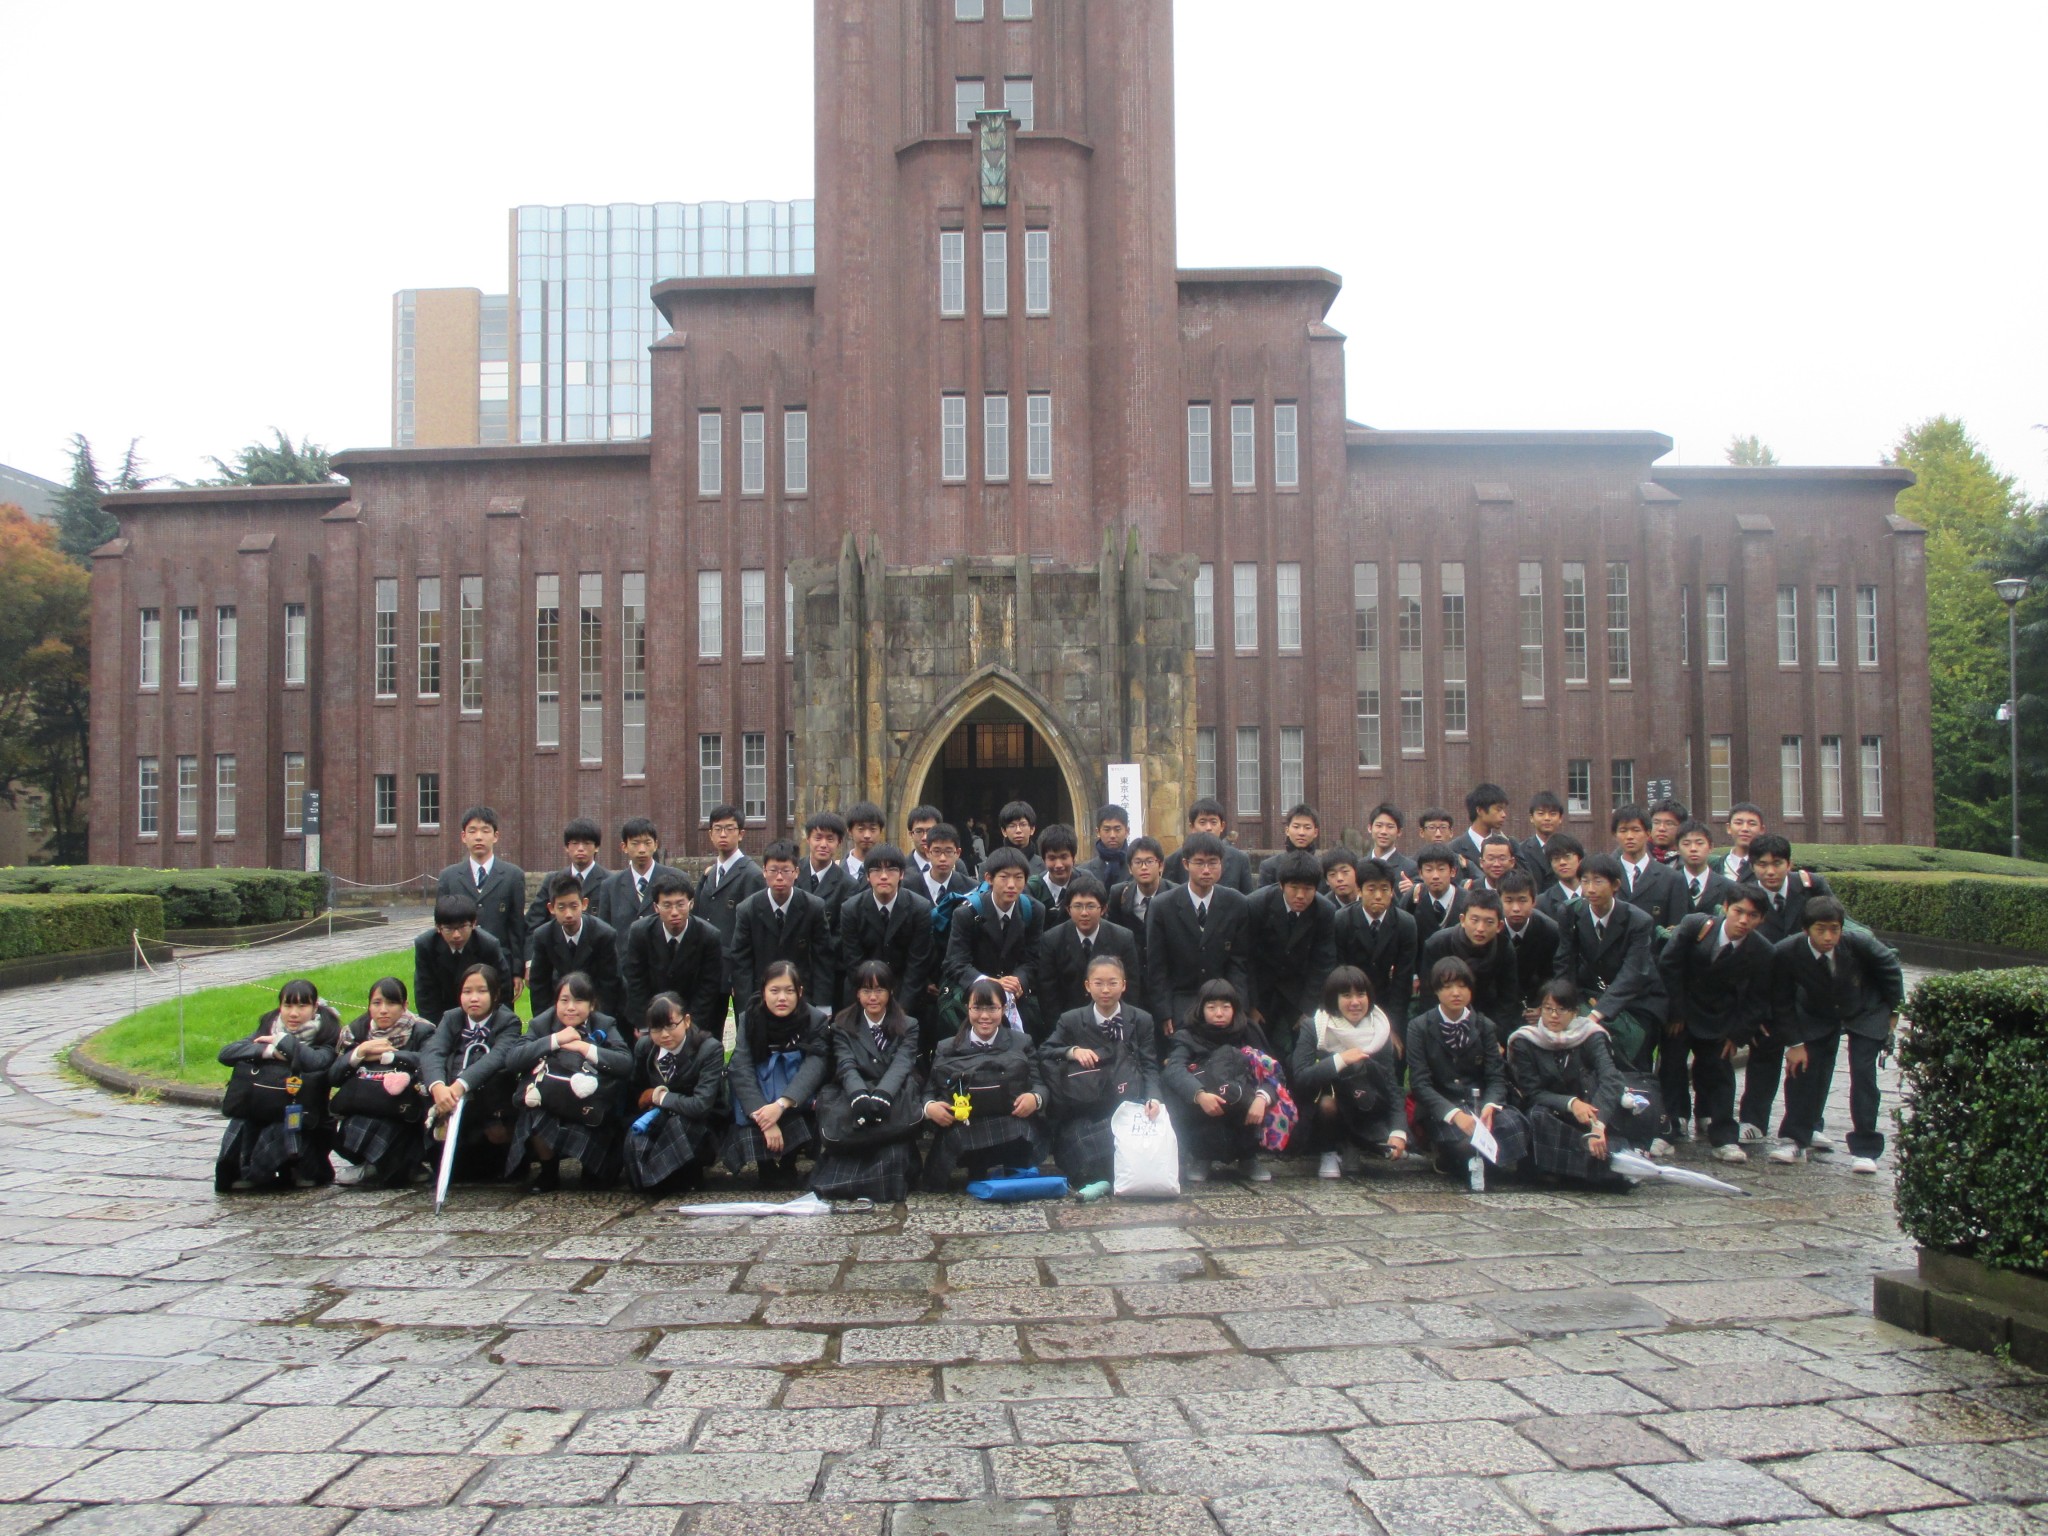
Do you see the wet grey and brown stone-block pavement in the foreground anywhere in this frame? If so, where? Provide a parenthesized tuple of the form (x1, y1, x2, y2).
(0, 930, 2048, 1536)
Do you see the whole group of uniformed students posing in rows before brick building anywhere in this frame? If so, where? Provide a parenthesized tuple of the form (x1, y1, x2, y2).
(217, 784, 1903, 1200)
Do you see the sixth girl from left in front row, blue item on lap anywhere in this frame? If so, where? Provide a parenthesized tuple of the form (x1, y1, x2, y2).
(721, 961, 831, 1190)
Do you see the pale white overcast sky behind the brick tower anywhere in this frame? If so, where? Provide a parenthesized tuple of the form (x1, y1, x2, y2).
(0, 0, 2048, 496)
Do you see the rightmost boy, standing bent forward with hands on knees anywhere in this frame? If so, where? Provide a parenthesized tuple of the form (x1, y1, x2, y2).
(1757, 897, 1905, 1174)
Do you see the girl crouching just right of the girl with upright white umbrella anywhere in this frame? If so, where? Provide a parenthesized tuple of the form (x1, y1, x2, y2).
(504, 971, 633, 1194)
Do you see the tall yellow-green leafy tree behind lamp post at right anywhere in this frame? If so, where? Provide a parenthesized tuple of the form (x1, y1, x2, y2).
(1892, 416, 2028, 854)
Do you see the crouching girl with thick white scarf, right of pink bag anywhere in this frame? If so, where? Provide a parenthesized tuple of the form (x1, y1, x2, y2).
(1292, 965, 1407, 1180)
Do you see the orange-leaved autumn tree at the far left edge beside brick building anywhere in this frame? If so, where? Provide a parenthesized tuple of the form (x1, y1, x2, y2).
(0, 507, 92, 862)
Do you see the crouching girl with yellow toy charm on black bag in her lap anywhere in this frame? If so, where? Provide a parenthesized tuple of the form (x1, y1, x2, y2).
(924, 977, 1044, 1192)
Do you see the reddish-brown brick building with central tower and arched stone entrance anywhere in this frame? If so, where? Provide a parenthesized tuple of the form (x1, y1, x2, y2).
(92, 0, 1933, 881)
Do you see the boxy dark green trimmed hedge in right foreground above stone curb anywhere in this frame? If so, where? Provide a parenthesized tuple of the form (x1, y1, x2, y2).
(1896, 967, 2048, 1272)
